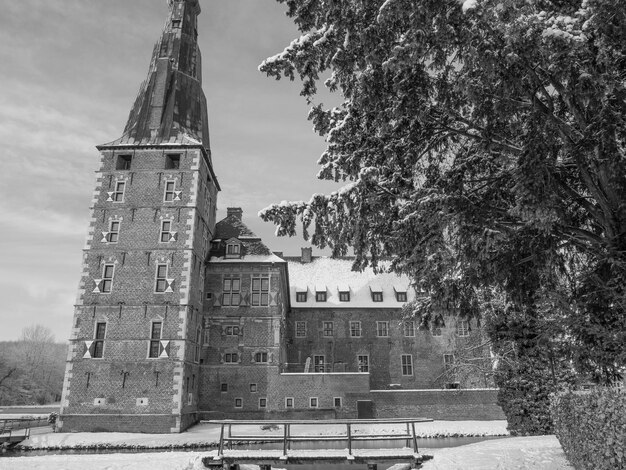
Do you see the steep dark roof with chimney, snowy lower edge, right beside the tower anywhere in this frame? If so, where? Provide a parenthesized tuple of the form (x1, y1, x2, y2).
(209, 207, 284, 262)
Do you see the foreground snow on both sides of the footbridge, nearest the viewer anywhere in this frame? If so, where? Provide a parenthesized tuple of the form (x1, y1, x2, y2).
(0, 436, 573, 470)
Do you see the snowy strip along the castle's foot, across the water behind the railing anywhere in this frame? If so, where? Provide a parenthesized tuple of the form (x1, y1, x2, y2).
(22, 420, 508, 449)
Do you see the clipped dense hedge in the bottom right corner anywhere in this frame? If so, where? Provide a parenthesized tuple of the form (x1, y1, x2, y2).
(550, 388, 626, 470)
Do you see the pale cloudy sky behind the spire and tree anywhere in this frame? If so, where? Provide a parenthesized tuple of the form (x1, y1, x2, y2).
(0, 0, 342, 341)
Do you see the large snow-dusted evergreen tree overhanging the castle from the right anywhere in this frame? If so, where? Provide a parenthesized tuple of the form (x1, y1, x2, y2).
(260, 0, 626, 432)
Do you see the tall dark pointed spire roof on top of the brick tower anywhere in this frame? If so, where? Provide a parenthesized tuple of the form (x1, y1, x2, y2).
(100, 0, 210, 158)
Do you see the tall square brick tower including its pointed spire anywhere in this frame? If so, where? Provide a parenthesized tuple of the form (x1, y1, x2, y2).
(60, 0, 219, 432)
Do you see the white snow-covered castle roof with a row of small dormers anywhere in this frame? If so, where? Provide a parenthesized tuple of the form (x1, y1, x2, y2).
(286, 257, 415, 309)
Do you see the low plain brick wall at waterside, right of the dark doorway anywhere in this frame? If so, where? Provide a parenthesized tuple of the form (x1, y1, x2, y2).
(370, 389, 506, 421)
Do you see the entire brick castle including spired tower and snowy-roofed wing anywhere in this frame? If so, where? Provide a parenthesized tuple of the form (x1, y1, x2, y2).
(59, 0, 502, 432)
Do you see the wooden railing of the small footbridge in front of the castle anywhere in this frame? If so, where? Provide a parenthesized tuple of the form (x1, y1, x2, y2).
(202, 418, 432, 461)
